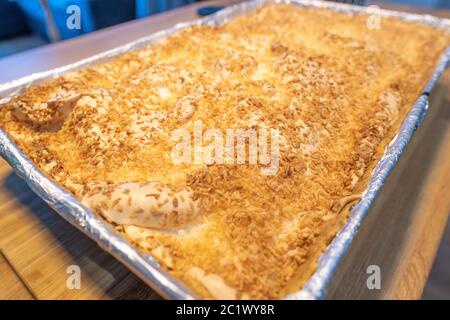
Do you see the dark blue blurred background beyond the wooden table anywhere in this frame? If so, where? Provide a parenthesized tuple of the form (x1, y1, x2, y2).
(0, 0, 450, 58)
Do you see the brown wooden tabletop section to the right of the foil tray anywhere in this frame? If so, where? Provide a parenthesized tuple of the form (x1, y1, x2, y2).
(328, 72, 450, 299)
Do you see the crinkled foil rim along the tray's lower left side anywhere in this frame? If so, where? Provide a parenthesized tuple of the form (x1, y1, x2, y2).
(0, 130, 196, 299)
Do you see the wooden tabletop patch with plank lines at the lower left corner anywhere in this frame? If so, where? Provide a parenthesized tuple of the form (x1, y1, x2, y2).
(0, 160, 158, 299)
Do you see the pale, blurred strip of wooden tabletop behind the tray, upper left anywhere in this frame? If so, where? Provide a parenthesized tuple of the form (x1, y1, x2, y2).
(0, 0, 242, 84)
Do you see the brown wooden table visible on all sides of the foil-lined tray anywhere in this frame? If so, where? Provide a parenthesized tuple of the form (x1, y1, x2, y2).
(0, 0, 450, 299)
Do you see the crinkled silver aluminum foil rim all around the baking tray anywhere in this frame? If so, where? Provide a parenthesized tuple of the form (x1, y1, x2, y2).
(0, 0, 450, 299)
